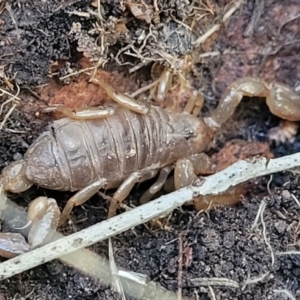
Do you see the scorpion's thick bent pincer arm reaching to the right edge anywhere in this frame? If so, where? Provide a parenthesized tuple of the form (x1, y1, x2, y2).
(205, 77, 300, 128)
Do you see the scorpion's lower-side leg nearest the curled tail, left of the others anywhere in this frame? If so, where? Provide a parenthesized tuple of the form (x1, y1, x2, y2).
(58, 179, 107, 226)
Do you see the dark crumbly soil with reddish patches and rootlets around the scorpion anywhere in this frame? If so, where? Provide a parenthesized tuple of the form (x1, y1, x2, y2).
(0, 0, 300, 300)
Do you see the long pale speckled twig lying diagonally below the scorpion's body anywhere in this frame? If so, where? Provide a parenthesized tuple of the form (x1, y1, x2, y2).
(0, 153, 300, 279)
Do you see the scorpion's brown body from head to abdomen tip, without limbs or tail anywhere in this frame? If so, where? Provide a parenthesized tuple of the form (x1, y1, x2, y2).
(24, 107, 212, 191)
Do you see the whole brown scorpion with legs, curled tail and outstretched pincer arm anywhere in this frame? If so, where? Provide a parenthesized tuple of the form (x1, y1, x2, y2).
(0, 70, 300, 257)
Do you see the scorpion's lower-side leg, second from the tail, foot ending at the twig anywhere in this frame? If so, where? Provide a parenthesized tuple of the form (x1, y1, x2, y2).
(108, 170, 157, 218)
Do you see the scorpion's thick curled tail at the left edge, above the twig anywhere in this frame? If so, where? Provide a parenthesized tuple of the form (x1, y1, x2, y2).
(0, 172, 60, 252)
